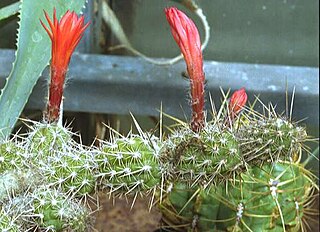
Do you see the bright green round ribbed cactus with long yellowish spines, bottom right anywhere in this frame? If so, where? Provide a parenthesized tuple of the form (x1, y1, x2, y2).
(215, 161, 314, 231)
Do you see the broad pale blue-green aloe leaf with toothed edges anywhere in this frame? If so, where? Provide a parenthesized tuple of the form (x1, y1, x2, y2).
(0, 0, 86, 138)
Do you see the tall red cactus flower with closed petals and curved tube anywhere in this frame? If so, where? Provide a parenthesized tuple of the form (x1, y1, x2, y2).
(165, 7, 205, 132)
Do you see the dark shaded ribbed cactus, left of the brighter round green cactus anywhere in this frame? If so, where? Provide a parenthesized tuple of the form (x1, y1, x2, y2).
(159, 183, 222, 232)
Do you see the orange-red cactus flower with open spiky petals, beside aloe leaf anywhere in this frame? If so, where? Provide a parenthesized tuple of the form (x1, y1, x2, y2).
(40, 9, 89, 122)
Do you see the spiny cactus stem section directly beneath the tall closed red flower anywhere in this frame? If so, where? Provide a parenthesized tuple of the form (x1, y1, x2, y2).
(161, 125, 242, 186)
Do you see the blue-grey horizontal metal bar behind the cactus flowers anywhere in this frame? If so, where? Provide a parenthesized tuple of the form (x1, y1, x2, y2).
(0, 50, 319, 128)
